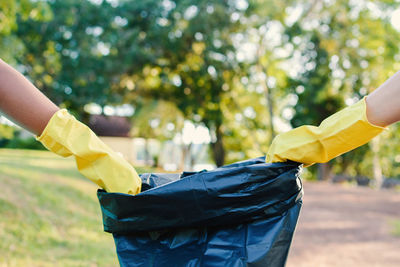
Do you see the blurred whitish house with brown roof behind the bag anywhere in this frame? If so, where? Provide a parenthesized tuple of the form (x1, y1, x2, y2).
(88, 115, 215, 171)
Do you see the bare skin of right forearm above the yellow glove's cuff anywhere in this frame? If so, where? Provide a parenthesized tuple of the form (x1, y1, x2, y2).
(367, 71, 400, 126)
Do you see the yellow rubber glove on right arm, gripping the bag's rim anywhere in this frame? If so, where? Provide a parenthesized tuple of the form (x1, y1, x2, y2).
(266, 98, 385, 166)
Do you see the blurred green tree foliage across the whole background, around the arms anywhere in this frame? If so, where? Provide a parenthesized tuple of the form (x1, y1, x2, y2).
(0, 0, 400, 176)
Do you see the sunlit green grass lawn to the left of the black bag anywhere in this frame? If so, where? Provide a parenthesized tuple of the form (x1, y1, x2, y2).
(0, 149, 153, 267)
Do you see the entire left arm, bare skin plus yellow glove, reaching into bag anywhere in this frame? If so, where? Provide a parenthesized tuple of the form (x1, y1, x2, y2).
(0, 60, 141, 194)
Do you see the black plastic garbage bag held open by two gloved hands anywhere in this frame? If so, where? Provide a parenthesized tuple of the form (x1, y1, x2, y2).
(98, 158, 302, 267)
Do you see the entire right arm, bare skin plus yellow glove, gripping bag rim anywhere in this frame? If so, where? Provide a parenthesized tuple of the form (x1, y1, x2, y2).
(267, 72, 400, 166)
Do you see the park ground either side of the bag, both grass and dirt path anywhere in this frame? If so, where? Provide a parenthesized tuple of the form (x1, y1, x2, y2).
(0, 149, 400, 267)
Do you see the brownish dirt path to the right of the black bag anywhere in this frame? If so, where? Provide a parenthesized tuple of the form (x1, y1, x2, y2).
(287, 183, 400, 267)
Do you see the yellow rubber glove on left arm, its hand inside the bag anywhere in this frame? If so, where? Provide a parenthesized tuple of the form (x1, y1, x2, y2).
(37, 109, 142, 194)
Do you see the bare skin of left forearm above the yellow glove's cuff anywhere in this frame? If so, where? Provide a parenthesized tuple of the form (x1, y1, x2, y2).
(0, 60, 59, 134)
